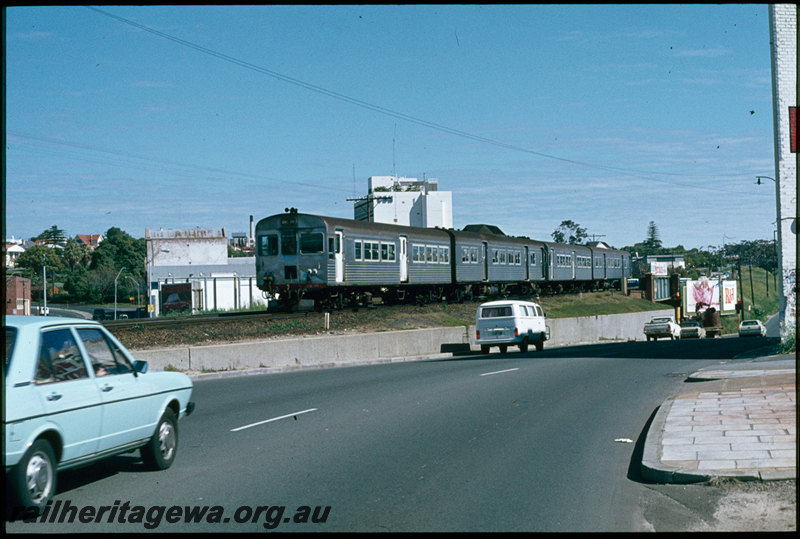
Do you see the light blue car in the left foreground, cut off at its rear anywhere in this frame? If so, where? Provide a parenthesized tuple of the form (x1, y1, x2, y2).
(3, 316, 194, 509)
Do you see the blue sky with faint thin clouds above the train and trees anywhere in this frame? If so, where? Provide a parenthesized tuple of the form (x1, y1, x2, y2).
(3, 4, 775, 248)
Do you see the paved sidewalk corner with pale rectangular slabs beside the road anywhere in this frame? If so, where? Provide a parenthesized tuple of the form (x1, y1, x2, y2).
(642, 356, 797, 483)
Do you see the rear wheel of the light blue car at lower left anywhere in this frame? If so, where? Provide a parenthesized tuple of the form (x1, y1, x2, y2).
(11, 439, 56, 511)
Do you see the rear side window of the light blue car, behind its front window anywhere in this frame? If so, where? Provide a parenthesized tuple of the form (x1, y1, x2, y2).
(34, 329, 89, 384)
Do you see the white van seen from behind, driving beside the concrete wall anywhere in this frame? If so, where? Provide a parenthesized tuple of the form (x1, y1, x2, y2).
(475, 300, 550, 354)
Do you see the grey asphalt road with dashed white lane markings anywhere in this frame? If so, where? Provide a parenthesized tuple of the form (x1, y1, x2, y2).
(7, 337, 780, 532)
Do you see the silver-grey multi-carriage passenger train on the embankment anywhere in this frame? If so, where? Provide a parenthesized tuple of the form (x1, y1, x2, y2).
(255, 209, 631, 309)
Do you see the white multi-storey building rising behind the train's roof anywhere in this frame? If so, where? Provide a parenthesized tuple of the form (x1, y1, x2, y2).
(348, 176, 453, 228)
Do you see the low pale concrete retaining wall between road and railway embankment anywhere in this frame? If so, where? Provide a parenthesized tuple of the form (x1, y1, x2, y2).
(132, 309, 673, 371)
